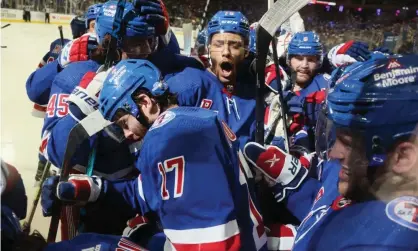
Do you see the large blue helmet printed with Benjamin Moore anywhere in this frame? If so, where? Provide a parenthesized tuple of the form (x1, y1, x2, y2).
(326, 55, 418, 167)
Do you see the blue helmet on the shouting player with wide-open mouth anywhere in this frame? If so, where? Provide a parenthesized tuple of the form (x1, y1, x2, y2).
(208, 10, 250, 42)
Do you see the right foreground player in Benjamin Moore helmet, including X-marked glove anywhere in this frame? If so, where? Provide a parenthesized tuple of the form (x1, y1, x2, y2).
(245, 56, 418, 250)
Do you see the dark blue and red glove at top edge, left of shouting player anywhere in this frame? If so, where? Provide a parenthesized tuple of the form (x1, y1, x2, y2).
(133, 0, 170, 35)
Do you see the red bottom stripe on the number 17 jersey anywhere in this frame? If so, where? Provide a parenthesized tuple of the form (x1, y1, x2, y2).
(173, 233, 241, 251)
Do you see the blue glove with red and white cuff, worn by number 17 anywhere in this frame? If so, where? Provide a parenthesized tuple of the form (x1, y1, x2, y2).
(41, 174, 104, 217)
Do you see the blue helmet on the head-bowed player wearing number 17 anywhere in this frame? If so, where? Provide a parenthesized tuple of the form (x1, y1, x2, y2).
(99, 59, 168, 121)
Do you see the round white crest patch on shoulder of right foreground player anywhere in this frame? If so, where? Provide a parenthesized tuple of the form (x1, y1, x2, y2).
(386, 196, 418, 231)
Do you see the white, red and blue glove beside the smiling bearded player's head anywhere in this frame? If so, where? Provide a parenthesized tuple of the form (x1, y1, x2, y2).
(328, 40, 370, 67)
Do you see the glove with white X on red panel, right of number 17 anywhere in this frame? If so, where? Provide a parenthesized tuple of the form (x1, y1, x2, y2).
(244, 142, 310, 201)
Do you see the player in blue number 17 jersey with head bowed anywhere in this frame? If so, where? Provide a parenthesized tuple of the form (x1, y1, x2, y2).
(42, 60, 266, 250)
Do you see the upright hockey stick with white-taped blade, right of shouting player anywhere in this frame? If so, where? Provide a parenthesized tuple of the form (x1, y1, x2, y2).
(255, 0, 310, 144)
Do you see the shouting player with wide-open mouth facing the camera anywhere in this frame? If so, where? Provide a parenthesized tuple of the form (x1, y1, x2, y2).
(167, 11, 255, 149)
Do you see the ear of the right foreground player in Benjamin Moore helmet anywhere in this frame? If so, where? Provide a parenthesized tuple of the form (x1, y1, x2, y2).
(391, 141, 418, 174)
